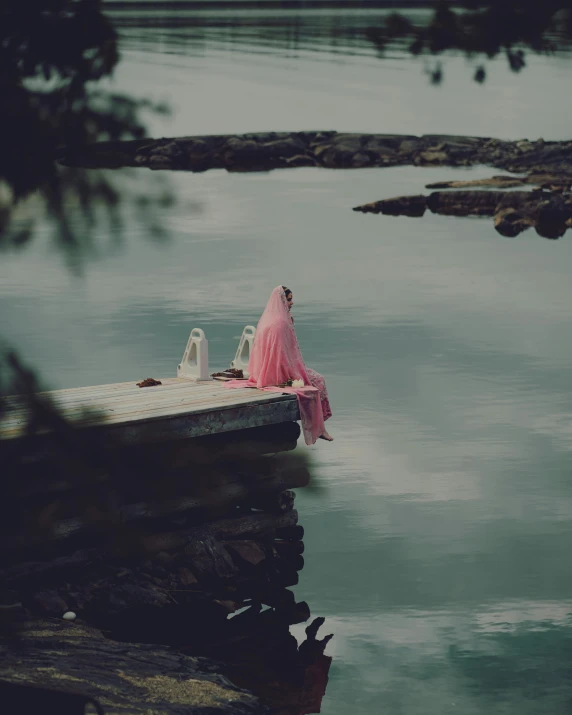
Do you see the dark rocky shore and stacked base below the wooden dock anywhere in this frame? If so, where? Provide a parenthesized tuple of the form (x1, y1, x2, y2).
(0, 422, 331, 715)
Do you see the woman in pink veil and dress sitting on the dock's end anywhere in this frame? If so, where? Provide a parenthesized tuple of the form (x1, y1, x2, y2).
(225, 286, 333, 444)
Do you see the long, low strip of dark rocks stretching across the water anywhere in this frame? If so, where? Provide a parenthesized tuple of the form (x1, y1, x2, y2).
(60, 131, 572, 175)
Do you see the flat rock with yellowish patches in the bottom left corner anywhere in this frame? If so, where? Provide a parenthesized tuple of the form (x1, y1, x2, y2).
(0, 619, 262, 715)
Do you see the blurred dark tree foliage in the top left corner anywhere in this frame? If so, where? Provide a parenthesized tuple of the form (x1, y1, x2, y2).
(0, 0, 170, 269)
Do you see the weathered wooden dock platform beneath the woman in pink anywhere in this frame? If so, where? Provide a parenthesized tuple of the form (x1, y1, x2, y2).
(0, 377, 299, 443)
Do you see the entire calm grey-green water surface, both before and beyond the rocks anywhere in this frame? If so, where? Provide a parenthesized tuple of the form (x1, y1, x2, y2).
(0, 11, 572, 715)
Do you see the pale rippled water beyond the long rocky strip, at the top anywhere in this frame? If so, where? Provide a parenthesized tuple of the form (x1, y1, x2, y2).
(101, 5, 569, 141)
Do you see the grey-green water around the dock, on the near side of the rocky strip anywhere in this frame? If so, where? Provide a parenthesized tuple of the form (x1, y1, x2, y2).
(0, 167, 572, 715)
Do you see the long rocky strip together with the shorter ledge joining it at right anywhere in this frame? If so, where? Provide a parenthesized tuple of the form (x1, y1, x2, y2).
(58, 131, 572, 239)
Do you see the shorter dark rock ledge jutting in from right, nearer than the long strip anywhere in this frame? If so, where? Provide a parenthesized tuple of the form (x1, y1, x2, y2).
(354, 190, 572, 238)
